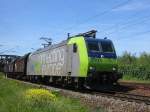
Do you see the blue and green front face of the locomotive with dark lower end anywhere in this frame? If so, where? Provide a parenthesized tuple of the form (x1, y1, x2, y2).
(85, 38, 121, 84)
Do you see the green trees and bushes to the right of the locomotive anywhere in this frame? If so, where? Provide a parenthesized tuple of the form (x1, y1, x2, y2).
(118, 52, 150, 80)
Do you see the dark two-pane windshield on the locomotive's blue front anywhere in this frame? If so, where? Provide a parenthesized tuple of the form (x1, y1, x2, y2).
(87, 41, 114, 52)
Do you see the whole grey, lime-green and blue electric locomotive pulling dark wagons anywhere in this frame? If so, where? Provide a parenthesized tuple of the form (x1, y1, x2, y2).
(4, 30, 122, 88)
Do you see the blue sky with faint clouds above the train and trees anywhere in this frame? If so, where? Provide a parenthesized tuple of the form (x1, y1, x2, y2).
(0, 0, 150, 55)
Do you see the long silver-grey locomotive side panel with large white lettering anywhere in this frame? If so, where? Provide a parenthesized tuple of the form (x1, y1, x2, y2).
(27, 45, 67, 76)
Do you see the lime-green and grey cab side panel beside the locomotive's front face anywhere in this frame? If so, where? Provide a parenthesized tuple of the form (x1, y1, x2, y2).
(68, 36, 88, 77)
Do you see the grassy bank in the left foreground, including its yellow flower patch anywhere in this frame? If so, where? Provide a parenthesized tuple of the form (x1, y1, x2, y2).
(0, 73, 102, 112)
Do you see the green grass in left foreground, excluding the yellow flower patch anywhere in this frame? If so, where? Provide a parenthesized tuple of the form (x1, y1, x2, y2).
(0, 73, 105, 112)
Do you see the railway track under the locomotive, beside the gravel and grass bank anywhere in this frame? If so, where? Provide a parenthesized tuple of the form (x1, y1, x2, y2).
(9, 78, 150, 105)
